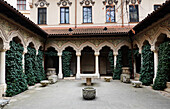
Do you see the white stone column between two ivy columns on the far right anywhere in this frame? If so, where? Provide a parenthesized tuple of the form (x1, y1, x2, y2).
(153, 50, 158, 82)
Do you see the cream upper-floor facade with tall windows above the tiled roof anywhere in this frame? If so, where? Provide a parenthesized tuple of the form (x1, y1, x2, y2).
(30, 0, 166, 27)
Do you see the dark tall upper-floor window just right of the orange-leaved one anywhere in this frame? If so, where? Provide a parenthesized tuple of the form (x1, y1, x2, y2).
(129, 5, 139, 22)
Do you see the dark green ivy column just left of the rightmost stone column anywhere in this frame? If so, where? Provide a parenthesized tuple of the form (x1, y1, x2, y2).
(139, 44, 154, 86)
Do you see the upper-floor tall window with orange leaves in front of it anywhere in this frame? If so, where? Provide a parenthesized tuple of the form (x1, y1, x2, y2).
(106, 6, 115, 22)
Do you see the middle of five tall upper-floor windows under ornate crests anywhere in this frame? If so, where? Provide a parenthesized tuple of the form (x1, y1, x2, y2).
(83, 7, 92, 23)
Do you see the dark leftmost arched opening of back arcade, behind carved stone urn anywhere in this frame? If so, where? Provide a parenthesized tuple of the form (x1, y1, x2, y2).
(45, 47, 59, 75)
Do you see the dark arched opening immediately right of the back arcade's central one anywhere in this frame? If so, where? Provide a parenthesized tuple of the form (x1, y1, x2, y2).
(99, 46, 114, 76)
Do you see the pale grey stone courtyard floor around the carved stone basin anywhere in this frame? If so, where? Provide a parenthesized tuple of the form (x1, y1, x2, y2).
(4, 79, 170, 109)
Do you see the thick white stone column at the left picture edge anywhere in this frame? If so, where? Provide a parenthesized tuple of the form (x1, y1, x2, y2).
(0, 50, 7, 96)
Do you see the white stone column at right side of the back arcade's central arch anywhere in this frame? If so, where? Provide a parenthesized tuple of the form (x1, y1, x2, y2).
(94, 52, 100, 78)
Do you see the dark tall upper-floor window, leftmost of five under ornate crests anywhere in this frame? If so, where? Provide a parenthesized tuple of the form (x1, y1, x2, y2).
(38, 8, 47, 24)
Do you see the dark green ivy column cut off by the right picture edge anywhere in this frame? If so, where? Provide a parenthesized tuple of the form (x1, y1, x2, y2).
(153, 41, 170, 90)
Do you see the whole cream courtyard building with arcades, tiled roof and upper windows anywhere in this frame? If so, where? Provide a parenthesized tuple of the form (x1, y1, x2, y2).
(0, 0, 170, 95)
